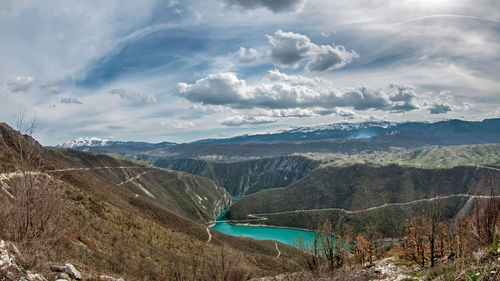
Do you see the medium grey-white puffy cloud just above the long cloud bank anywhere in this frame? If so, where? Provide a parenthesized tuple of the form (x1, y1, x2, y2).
(267, 30, 359, 72)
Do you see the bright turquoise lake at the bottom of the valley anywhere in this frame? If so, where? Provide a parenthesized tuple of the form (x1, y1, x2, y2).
(212, 212, 314, 248)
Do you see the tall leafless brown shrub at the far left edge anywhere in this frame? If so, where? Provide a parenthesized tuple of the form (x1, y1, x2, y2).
(0, 112, 64, 269)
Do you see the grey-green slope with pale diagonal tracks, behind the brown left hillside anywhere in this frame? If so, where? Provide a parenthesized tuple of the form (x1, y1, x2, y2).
(47, 149, 231, 224)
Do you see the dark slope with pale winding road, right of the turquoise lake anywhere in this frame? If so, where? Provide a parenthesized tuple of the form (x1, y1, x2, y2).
(226, 164, 500, 237)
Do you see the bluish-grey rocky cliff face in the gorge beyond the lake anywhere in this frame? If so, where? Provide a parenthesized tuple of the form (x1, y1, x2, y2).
(154, 156, 320, 196)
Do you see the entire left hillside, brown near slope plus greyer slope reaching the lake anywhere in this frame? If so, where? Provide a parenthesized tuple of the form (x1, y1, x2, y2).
(0, 124, 300, 280)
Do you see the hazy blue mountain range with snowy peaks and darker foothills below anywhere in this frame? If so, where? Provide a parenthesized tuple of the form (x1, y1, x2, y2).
(60, 119, 500, 161)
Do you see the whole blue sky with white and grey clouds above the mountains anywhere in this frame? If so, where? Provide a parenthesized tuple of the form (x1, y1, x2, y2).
(0, 0, 500, 145)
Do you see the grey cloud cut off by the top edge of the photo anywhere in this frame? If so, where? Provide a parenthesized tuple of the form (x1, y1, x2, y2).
(226, 0, 305, 13)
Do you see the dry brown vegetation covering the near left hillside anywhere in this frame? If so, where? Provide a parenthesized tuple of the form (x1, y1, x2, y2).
(0, 119, 301, 281)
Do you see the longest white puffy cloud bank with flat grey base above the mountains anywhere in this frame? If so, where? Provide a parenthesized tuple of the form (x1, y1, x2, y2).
(177, 70, 463, 118)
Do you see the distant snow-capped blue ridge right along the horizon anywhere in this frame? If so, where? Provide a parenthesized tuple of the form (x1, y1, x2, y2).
(57, 118, 500, 152)
